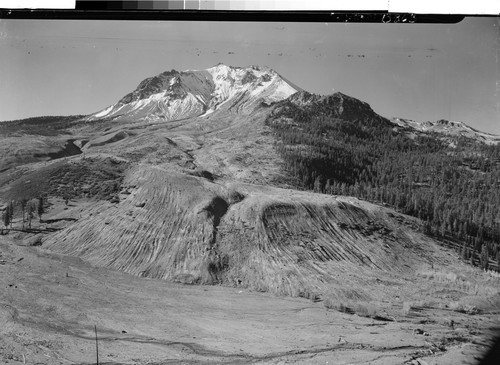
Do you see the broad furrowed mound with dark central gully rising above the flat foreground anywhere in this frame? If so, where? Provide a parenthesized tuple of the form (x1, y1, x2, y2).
(43, 166, 444, 300)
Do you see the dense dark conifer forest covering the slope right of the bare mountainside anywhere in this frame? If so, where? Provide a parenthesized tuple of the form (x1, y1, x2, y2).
(267, 102, 500, 267)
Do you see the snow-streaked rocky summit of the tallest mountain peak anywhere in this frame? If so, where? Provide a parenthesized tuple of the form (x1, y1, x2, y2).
(89, 64, 301, 120)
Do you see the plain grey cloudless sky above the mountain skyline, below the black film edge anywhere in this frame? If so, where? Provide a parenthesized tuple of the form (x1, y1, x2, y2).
(0, 17, 500, 134)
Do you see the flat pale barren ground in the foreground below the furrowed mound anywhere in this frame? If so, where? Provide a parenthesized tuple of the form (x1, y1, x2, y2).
(0, 233, 498, 364)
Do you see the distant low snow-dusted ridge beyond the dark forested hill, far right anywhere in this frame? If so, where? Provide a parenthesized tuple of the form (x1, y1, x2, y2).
(392, 118, 500, 144)
